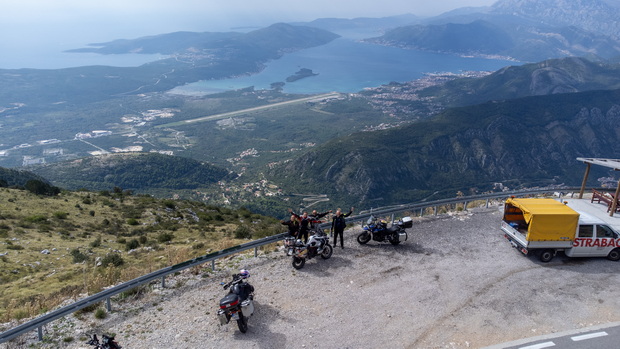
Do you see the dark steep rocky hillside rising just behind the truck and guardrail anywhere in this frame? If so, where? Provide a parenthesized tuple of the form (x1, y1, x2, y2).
(271, 90, 620, 205)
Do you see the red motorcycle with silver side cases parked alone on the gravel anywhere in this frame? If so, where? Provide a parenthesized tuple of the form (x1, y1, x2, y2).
(217, 270, 254, 333)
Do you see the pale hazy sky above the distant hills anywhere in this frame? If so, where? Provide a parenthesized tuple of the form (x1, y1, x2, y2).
(0, 0, 496, 68)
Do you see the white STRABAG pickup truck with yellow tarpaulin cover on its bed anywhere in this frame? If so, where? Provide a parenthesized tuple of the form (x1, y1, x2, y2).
(501, 198, 620, 262)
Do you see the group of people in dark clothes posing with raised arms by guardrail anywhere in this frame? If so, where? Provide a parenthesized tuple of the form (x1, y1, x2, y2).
(280, 207, 354, 249)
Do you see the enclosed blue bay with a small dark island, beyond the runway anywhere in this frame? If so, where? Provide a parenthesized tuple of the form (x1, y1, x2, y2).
(170, 38, 522, 95)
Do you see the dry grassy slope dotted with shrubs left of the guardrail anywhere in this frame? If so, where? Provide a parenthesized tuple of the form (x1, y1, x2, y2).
(0, 188, 281, 322)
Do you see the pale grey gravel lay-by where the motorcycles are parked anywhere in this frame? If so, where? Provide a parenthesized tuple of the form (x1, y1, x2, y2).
(0, 208, 620, 349)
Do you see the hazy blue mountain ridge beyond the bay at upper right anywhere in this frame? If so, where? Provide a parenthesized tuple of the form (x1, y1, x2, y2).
(366, 0, 620, 62)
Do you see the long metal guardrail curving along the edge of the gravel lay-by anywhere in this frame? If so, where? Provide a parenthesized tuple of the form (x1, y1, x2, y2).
(0, 187, 580, 343)
